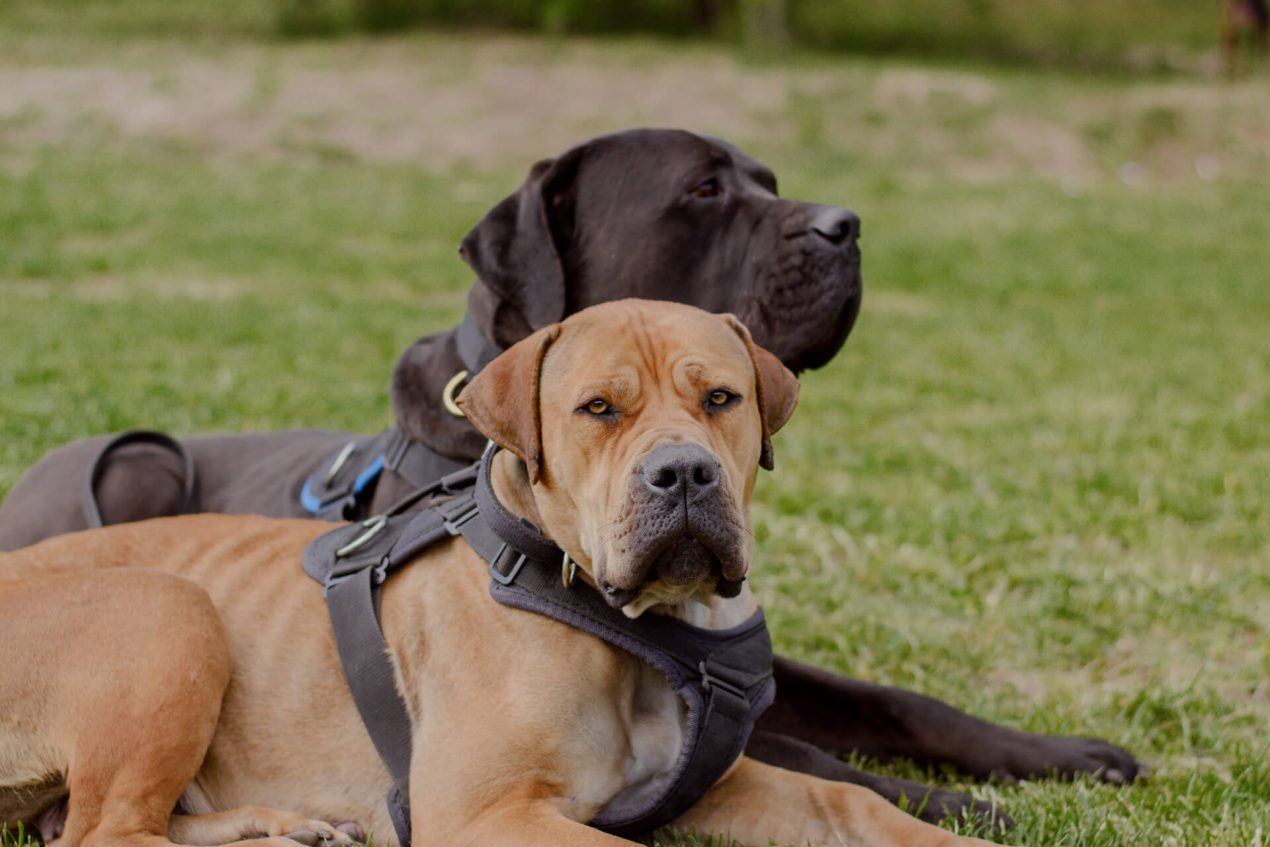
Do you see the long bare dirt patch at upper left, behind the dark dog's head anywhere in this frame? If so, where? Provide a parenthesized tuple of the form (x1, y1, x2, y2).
(0, 42, 784, 171)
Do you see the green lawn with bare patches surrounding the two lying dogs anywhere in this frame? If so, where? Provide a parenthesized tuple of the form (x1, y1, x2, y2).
(0, 0, 1270, 847)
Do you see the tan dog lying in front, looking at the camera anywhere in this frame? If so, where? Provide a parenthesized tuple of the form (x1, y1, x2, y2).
(0, 301, 986, 847)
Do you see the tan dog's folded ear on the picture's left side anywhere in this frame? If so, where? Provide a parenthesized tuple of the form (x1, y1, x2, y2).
(455, 324, 560, 484)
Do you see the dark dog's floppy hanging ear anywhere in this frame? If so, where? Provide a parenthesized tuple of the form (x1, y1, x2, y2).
(458, 146, 585, 329)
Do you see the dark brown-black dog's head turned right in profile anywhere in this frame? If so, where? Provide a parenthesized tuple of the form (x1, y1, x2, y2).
(461, 130, 861, 371)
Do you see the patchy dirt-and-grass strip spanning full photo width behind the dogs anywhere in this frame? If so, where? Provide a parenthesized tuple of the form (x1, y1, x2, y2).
(0, 37, 1270, 185)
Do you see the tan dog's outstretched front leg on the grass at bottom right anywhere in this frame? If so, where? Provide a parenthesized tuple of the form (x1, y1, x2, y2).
(674, 757, 988, 847)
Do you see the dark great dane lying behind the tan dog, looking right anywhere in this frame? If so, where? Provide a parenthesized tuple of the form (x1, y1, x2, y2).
(0, 130, 1143, 823)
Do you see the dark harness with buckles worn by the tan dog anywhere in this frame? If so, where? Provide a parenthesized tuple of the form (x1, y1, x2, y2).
(304, 447, 776, 847)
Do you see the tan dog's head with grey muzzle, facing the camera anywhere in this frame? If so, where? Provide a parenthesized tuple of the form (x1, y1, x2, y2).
(458, 300, 798, 617)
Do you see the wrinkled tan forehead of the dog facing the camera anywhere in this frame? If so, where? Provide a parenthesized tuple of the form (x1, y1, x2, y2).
(542, 302, 754, 397)
